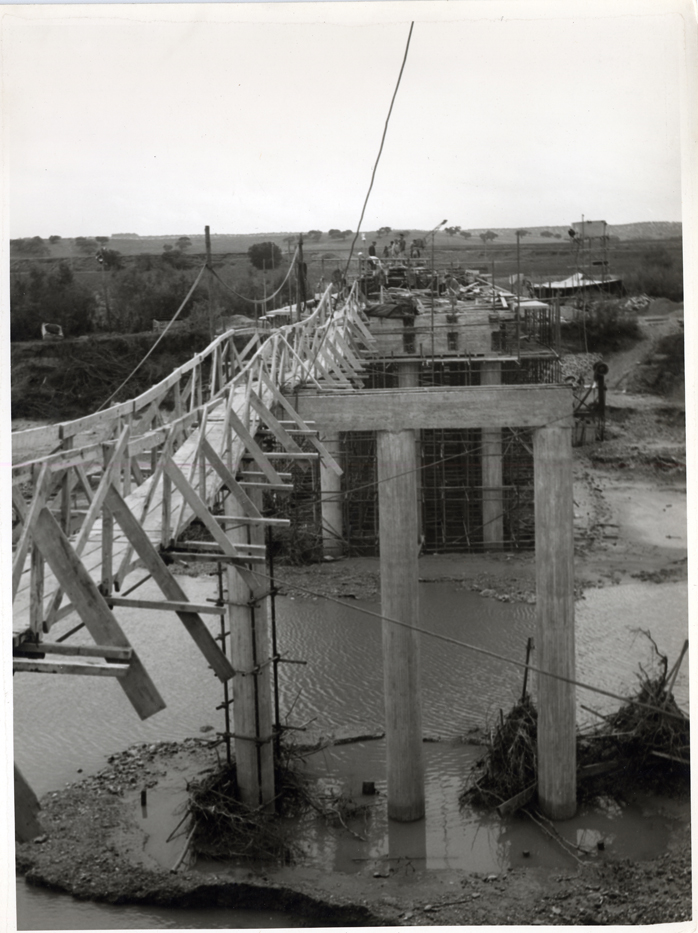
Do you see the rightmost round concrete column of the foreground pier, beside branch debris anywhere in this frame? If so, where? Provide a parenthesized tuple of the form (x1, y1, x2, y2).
(533, 423, 577, 820)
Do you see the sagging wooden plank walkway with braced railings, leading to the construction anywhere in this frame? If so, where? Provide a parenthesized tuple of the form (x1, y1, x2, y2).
(12, 282, 373, 718)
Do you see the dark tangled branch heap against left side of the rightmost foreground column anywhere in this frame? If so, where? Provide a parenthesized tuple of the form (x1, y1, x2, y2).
(459, 694, 538, 809)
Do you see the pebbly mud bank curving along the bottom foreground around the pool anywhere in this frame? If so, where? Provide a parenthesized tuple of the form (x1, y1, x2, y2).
(17, 739, 691, 926)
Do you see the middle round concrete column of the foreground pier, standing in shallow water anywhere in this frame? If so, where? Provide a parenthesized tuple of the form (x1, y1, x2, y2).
(377, 431, 424, 822)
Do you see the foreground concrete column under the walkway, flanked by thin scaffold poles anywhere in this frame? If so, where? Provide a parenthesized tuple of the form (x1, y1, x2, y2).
(225, 490, 274, 810)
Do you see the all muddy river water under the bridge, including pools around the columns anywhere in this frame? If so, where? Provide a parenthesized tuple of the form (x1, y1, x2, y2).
(14, 576, 688, 929)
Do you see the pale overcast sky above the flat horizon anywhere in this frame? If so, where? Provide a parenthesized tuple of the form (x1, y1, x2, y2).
(3, 0, 691, 237)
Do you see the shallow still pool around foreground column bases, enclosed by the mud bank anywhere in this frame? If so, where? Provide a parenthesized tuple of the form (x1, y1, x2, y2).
(190, 740, 675, 879)
